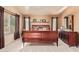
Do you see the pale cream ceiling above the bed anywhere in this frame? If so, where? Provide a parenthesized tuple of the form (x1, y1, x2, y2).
(15, 6, 67, 15)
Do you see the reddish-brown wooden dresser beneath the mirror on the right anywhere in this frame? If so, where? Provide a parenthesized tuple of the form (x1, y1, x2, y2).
(59, 32, 78, 46)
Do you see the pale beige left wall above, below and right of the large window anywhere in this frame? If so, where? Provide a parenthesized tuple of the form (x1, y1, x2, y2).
(3, 6, 22, 45)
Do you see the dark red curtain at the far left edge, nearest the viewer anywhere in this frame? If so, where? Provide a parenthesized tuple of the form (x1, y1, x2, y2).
(0, 6, 4, 49)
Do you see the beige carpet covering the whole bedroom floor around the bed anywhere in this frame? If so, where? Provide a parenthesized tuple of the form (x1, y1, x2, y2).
(0, 39, 79, 52)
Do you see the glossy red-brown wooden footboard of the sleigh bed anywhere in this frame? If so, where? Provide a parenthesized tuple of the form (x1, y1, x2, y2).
(22, 31, 58, 46)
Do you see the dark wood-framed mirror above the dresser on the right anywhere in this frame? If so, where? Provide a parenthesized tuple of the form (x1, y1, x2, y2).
(64, 15, 74, 31)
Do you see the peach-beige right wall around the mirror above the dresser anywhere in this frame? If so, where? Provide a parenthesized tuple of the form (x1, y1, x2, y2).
(59, 6, 79, 32)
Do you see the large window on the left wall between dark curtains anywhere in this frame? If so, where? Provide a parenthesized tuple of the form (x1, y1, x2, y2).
(4, 12, 15, 34)
